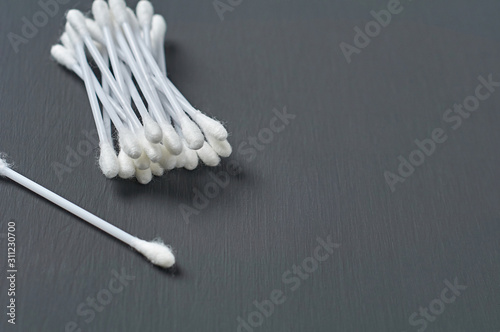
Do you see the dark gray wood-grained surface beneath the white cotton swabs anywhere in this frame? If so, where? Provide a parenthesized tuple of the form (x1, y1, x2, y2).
(0, 0, 500, 332)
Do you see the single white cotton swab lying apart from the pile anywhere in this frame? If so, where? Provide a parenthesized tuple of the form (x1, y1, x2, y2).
(0, 159, 175, 268)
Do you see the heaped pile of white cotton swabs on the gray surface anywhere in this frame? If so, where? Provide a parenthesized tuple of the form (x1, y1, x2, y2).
(51, 0, 232, 184)
